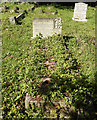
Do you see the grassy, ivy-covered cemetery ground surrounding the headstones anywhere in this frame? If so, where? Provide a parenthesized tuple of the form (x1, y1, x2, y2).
(0, 2, 97, 120)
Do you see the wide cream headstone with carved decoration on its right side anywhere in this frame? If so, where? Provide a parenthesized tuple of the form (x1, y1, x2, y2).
(33, 17, 62, 38)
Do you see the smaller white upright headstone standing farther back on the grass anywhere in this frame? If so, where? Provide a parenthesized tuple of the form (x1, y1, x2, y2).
(72, 3, 88, 22)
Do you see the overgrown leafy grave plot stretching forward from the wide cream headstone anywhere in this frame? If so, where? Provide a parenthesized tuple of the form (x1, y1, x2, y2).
(25, 36, 80, 118)
